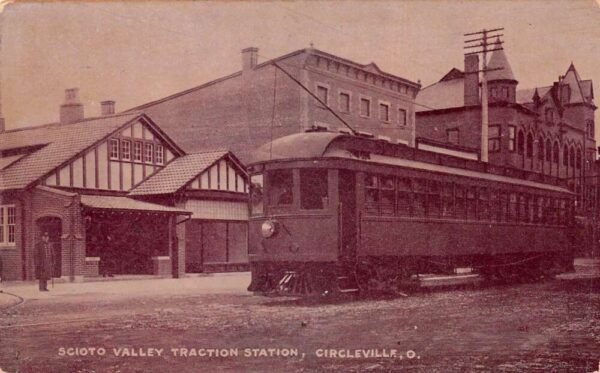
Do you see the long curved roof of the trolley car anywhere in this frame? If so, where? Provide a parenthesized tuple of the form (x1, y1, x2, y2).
(252, 132, 573, 194)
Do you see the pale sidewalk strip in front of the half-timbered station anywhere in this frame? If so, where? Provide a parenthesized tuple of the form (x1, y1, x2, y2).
(0, 272, 250, 310)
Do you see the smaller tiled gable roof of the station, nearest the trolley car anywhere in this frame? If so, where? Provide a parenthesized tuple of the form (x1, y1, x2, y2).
(129, 150, 245, 196)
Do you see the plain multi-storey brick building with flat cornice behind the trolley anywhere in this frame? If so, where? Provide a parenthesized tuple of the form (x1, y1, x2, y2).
(131, 48, 420, 162)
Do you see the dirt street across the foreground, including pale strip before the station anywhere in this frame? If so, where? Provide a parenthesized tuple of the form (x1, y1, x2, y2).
(0, 274, 600, 373)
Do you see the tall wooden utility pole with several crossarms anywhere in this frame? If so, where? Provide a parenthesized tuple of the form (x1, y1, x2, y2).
(464, 27, 504, 163)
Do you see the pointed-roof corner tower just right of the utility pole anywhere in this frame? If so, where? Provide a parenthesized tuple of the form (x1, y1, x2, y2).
(487, 39, 519, 104)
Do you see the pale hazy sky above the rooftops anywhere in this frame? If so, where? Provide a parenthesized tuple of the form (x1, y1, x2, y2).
(0, 0, 600, 129)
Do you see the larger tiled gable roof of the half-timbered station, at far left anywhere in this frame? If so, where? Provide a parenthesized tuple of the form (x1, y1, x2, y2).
(0, 112, 182, 190)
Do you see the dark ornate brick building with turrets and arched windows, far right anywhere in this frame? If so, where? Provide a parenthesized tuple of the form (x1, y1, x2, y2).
(416, 45, 596, 208)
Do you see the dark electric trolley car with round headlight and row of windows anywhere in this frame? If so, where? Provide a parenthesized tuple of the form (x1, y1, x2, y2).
(248, 131, 574, 293)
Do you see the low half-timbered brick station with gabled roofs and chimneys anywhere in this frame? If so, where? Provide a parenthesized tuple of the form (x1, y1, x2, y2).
(0, 89, 246, 280)
